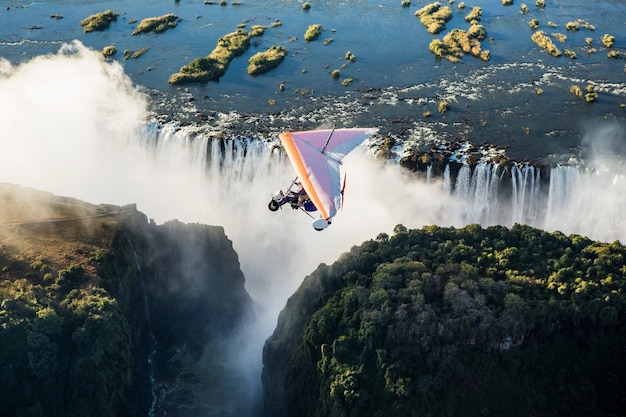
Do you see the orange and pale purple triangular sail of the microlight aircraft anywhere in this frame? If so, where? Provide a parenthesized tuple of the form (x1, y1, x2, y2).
(279, 128, 378, 223)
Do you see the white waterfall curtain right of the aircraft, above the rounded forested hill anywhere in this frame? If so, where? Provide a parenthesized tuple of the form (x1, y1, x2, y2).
(442, 160, 626, 241)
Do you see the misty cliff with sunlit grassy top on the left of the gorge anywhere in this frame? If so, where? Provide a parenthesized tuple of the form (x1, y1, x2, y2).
(0, 185, 253, 416)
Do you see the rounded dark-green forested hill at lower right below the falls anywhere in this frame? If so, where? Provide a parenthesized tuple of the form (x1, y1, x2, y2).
(263, 225, 626, 417)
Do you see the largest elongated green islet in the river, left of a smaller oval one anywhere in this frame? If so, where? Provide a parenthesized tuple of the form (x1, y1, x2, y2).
(169, 29, 250, 84)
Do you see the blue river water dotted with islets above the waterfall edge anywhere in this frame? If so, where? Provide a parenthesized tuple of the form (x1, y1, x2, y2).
(0, 0, 626, 163)
